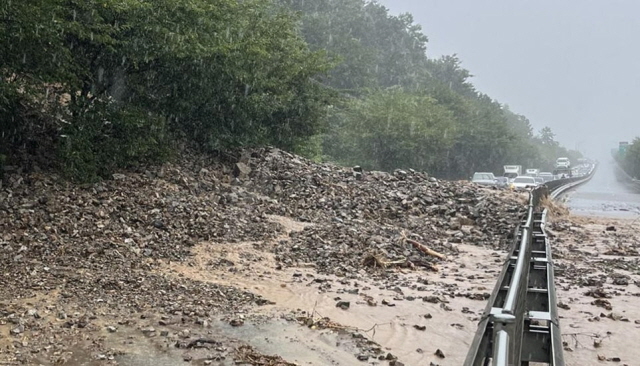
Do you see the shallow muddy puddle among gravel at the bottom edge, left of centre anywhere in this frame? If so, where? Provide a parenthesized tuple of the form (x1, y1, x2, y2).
(57, 319, 366, 366)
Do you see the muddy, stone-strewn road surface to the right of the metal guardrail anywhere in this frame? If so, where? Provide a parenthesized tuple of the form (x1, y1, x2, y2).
(549, 215, 640, 366)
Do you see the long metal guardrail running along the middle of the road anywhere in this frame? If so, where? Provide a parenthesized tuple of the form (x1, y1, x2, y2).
(464, 167, 595, 366)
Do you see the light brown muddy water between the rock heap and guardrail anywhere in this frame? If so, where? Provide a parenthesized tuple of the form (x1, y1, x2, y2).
(164, 237, 505, 365)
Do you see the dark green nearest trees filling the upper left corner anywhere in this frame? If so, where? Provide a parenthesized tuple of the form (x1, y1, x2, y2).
(0, 0, 332, 180)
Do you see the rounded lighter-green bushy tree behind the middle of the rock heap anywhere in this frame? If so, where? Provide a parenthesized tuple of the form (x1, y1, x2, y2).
(329, 88, 453, 171)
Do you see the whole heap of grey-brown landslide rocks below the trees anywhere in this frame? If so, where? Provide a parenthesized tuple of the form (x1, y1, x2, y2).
(0, 149, 525, 363)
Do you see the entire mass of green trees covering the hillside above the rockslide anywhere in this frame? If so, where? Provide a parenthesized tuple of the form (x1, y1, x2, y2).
(0, 0, 573, 181)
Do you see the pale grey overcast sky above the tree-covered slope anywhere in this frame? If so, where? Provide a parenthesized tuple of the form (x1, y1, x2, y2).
(379, 0, 640, 157)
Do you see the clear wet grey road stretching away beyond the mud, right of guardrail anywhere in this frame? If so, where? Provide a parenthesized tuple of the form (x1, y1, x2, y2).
(565, 162, 640, 219)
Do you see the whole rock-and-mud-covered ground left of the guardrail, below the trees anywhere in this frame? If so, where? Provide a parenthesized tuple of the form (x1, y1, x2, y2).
(0, 149, 524, 365)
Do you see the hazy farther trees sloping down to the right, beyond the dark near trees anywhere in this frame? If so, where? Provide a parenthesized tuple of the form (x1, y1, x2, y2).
(280, 0, 579, 178)
